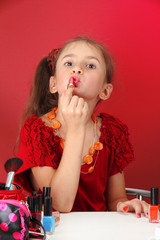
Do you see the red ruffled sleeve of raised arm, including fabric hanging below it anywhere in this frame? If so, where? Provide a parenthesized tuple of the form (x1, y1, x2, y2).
(15, 115, 60, 191)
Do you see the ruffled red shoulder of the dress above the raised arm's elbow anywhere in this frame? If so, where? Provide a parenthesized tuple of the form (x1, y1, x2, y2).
(19, 115, 61, 168)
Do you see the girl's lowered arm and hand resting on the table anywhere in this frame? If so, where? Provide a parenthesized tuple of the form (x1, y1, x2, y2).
(106, 172, 148, 217)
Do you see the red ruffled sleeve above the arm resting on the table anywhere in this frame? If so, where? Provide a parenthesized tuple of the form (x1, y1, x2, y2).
(100, 114, 134, 176)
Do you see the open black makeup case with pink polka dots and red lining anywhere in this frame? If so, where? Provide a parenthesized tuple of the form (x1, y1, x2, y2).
(0, 183, 46, 240)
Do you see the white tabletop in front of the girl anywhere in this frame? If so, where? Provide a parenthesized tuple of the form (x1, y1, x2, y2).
(47, 212, 160, 240)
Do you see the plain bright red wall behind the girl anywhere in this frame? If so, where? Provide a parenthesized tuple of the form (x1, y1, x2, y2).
(0, 0, 160, 189)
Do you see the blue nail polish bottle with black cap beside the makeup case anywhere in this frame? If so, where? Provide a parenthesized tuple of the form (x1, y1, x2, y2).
(42, 197, 55, 235)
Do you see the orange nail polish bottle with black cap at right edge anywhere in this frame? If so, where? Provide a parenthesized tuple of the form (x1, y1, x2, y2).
(148, 188, 159, 223)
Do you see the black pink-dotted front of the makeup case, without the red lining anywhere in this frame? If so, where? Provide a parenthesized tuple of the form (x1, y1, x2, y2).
(0, 199, 46, 240)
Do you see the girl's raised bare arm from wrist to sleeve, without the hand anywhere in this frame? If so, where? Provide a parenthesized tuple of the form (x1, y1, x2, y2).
(31, 125, 83, 212)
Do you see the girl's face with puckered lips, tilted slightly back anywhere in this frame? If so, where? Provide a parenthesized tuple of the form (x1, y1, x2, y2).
(54, 41, 107, 101)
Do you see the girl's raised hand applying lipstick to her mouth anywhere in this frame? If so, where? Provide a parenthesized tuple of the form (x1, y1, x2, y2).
(58, 88, 88, 129)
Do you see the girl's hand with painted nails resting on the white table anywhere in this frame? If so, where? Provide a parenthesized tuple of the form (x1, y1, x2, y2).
(117, 198, 149, 218)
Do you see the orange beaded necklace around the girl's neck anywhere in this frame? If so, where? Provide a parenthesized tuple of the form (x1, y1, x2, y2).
(47, 107, 103, 174)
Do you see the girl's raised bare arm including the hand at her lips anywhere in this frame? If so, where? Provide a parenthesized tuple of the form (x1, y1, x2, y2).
(31, 86, 88, 212)
